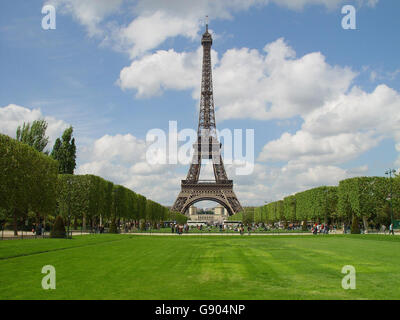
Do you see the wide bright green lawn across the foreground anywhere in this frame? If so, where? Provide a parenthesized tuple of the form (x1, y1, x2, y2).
(0, 234, 400, 300)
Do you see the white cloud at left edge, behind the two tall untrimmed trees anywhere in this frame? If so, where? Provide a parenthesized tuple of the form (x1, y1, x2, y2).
(0, 104, 68, 149)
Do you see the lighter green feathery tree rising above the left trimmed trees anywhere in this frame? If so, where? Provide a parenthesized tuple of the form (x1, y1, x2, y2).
(17, 119, 49, 154)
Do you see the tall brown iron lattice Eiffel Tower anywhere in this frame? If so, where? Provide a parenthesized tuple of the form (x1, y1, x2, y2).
(172, 19, 243, 215)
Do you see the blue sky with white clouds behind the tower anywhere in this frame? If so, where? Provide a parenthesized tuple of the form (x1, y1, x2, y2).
(0, 0, 400, 205)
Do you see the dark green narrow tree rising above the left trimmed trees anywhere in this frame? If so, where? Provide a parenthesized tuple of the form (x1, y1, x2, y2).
(51, 127, 76, 174)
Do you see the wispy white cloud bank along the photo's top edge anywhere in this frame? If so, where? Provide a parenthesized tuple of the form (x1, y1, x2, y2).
(51, 0, 378, 58)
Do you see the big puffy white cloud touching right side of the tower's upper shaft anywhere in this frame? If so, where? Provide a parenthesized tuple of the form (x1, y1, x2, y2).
(215, 39, 356, 119)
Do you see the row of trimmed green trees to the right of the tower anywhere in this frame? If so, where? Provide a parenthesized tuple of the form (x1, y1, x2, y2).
(230, 176, 400, 230)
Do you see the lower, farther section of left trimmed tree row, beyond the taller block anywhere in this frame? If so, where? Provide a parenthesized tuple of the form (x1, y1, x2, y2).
(55, 174, 182, 232)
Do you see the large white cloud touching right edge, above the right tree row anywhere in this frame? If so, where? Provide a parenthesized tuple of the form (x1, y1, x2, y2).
(259, 85, 400, 169)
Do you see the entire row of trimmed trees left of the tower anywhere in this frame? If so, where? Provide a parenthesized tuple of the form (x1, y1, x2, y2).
(0, 134, 185, 233)
